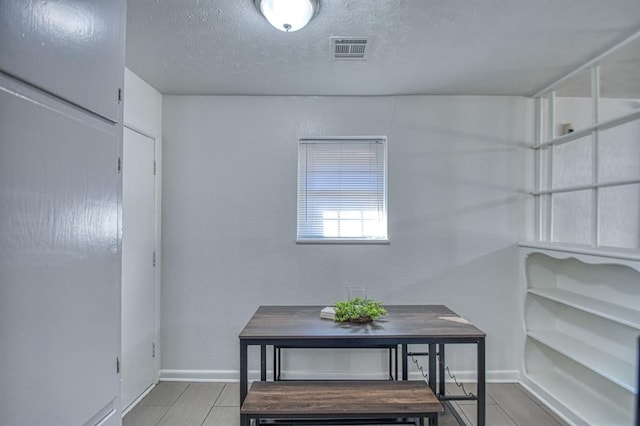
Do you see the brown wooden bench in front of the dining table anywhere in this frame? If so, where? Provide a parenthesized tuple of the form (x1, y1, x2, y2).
(240, 380, 443, 426)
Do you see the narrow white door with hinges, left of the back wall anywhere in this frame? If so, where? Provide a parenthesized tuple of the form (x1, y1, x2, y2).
(121, 128, 155, 409)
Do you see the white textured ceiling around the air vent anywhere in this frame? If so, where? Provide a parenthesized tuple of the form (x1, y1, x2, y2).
(127, 0, 640, 95)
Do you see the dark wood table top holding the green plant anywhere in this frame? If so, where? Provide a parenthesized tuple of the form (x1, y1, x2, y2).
(240, 305, 485, 340)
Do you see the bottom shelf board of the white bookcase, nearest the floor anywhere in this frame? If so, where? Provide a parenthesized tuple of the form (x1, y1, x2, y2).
(526, 372, 632, 426)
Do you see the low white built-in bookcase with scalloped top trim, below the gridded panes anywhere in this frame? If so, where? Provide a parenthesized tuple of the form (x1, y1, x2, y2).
(520, 243, 640, 426)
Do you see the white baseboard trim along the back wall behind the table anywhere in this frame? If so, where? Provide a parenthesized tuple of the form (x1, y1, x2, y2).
(160, 370, 520, 383)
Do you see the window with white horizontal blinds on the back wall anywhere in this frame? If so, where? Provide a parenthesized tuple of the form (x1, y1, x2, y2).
(297, 138, 387, 242)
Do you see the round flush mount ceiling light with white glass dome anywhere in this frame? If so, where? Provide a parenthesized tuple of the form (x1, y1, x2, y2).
(255, 0, 318, 32)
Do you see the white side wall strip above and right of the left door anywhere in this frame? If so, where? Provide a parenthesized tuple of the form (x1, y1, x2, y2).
(124, 68, 162, 380)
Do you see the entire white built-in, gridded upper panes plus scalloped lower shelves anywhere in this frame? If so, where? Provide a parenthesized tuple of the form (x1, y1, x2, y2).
(520, 24, 640, 426)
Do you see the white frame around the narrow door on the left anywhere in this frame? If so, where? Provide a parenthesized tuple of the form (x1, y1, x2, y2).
(121, 120, 162, 417)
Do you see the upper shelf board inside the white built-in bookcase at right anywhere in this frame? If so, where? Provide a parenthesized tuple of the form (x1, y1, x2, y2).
(527, 288, 640, 330)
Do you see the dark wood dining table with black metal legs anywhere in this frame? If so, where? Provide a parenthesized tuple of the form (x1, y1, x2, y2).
(239, 305, 486, 426)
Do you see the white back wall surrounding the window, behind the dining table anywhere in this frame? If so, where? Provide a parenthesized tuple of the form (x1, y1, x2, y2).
(162, 96, 533, 379)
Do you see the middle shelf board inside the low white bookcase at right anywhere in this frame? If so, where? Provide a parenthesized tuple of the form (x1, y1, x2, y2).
(527, 330, 635, 392)
